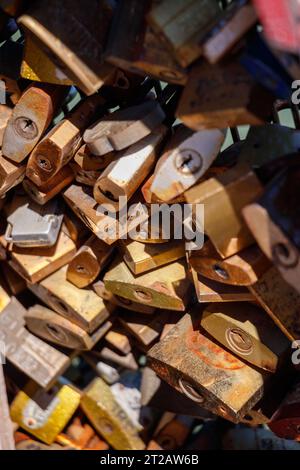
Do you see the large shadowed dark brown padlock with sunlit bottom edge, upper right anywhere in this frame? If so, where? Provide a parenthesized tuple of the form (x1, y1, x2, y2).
(176, 62, 274, 130)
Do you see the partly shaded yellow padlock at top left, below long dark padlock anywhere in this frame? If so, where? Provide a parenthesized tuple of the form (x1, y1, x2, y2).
(20, 33, 74, 85)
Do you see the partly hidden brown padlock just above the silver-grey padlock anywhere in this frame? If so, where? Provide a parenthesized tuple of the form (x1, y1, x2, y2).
(23, 165, 75, 206)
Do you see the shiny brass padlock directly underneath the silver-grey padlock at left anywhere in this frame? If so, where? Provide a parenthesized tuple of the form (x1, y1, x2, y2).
(4, 230, 76, 283)
